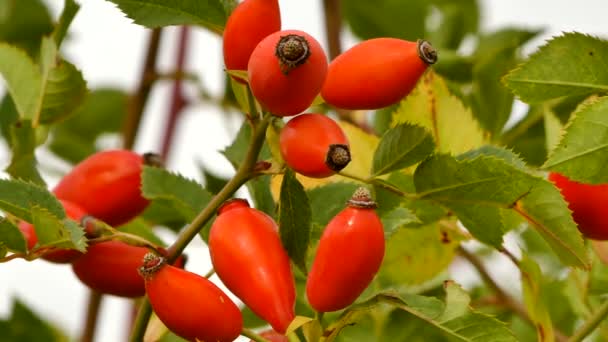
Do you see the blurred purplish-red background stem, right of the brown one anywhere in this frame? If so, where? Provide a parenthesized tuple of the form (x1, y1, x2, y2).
(160, 26, 190, 161)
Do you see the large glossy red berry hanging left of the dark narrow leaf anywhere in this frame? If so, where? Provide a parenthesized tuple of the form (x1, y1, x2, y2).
(209, 199, 296, 333)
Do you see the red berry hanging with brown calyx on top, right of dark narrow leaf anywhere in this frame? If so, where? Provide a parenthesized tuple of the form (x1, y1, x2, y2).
(306, 188, 384, 312)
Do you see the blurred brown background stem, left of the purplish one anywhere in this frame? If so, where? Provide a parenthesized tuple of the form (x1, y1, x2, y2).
(123, 28, 162, 150)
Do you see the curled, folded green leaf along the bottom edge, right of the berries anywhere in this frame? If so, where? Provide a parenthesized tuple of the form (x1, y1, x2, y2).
(327, 281, 517, 342)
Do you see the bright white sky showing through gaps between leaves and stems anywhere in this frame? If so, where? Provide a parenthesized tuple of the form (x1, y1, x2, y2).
(0, 0, 608, 342)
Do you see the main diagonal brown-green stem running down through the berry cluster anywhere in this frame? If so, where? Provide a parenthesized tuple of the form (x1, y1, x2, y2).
(130, 114, 271, 342)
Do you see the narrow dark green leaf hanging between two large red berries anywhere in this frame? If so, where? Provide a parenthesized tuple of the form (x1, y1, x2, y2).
(279, 170, 312, 273)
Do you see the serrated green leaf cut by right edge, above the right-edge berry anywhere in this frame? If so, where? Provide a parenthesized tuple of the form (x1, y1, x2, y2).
(543, 97, 608, 184)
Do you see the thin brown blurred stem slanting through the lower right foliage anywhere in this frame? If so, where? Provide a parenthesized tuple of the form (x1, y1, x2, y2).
(458, 246, 567, 342)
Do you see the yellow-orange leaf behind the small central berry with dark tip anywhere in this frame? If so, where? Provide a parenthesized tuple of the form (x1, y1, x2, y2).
(270, 121, 380, 201)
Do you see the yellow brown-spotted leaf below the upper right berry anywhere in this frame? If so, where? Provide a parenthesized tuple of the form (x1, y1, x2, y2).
(392, 71, 486, 154)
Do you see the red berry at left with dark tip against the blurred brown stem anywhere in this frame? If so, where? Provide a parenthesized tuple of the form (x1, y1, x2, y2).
(53, 150, 149, 226)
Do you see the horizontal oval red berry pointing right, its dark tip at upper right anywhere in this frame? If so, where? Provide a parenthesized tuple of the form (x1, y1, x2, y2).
(321, 38, 437, 109)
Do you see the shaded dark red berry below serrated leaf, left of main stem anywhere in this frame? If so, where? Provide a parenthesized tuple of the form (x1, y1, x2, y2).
(72, 241, 148, 298)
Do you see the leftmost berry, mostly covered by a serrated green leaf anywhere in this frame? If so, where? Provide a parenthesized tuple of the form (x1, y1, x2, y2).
(19, 200, 86, 264)
